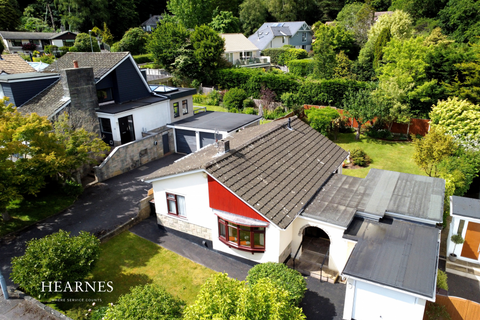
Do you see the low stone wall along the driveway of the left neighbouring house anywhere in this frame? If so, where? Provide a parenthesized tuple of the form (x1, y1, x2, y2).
(94, 128, 175, 182)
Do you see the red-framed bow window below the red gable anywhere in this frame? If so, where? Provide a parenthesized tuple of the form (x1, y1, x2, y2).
(218, 218, 265, 252)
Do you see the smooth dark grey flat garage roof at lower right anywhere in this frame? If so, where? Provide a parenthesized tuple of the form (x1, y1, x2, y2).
(343, 218, 440, 299)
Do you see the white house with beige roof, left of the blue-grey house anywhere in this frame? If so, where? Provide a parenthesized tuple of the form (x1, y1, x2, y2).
(220, 33, 270, 68)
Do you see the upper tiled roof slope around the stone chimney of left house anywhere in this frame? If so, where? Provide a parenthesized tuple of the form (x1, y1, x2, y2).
(42, 52, 130, 80)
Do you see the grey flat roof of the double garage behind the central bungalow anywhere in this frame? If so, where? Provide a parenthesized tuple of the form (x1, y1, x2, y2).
(168, 111, 262, 132)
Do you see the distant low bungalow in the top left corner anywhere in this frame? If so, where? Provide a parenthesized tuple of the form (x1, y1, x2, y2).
(0, 31, 77, 53)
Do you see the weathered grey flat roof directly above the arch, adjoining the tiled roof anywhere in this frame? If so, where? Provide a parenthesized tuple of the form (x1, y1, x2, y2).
(302, 174, 364, 228)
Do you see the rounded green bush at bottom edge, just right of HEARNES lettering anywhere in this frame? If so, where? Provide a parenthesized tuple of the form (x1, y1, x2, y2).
(102, 284, 185, 320)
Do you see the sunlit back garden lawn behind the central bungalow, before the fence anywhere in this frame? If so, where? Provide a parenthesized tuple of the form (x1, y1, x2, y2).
(334, 133, 425, 178)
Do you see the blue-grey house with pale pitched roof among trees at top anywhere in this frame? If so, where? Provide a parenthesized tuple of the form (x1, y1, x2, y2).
(248, 21, 313, 51)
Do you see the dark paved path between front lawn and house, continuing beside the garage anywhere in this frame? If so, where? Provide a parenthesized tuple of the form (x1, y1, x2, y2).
(130, 217, 345, 320)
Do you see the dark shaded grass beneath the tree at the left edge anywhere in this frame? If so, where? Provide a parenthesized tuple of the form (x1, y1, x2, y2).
(0, 192, 77, 237)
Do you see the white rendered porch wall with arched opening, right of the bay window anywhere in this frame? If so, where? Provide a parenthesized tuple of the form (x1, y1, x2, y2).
(292, 216, 351, 273)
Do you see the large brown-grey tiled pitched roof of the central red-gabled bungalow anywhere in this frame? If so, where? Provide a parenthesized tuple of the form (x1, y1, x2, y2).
(145, 118, 347, 229)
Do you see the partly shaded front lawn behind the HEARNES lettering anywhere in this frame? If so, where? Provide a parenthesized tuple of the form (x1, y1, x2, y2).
(52, 231, 215, 319)
